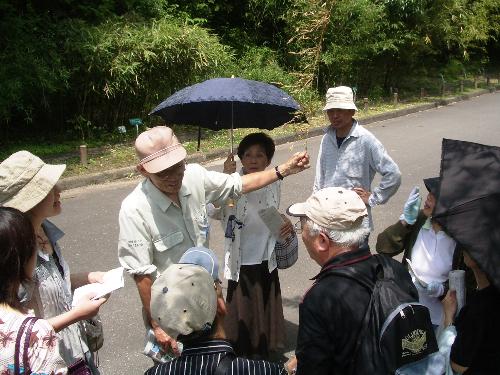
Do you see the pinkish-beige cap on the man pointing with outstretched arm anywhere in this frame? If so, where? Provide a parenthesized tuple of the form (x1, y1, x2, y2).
(135, 126, 187, 173)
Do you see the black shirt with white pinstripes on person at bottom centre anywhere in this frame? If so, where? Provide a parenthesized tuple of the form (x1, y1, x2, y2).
(145, 340, 287, 375)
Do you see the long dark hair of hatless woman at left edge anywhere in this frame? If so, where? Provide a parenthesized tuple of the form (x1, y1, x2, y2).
(0, 207, 36, 309)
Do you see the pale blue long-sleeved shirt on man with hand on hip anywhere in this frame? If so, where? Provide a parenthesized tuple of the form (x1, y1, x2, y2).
(313, 120, 401, 229)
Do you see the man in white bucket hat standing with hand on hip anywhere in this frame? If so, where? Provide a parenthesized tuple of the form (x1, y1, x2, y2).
(313, 86, 401, 229)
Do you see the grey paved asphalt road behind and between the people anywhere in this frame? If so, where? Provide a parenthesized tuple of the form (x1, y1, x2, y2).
(54, 93, 500, 375)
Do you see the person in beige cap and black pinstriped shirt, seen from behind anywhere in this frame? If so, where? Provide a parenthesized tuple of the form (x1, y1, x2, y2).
(145, 247, 291, 375)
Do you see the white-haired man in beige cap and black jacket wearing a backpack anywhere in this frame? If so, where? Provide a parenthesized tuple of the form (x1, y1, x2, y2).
(288, 187, 437, 375)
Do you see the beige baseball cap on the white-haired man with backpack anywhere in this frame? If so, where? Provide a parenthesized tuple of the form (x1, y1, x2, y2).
(287, 187, 368, 230)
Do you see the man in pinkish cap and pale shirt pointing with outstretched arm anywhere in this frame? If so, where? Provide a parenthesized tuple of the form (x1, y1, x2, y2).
(118, 126, 309, 352)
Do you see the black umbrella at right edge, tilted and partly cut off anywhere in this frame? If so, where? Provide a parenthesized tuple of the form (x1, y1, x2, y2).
(433, 139, 500, 289)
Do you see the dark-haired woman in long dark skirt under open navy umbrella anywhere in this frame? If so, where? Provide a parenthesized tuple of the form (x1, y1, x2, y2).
(208, 133, 298, 359)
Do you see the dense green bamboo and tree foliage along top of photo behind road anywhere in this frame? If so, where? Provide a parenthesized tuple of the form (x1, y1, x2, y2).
(0, 0, 500, 142)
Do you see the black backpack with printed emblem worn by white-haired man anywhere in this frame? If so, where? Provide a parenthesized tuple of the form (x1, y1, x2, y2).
(325, 255, 442, 375)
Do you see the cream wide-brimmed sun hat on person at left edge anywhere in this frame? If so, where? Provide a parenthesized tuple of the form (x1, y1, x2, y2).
(0, 151, 66, 212)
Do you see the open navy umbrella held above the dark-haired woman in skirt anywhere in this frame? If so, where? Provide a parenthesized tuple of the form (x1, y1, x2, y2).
(150, 78, 299, 151)
